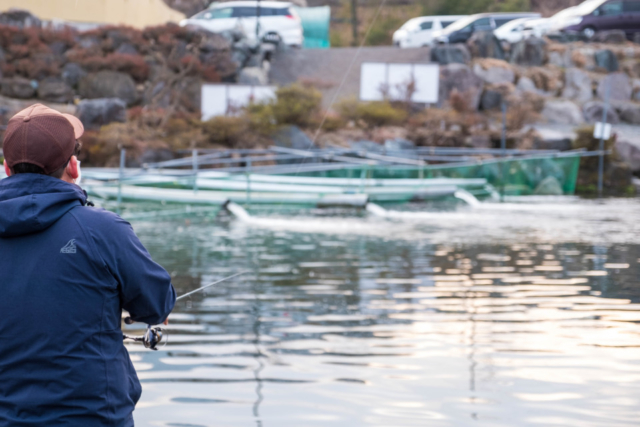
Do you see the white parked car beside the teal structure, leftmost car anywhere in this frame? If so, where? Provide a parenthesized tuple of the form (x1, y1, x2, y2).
(180, 1, 304, 46)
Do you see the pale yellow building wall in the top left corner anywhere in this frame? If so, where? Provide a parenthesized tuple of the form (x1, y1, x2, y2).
(0, 0, 185, 28)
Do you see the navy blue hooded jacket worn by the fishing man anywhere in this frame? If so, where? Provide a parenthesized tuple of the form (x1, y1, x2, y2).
(0, 174, 176, 427)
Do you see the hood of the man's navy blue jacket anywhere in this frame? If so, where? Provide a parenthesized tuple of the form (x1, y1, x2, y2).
(0, 173, 87, 237)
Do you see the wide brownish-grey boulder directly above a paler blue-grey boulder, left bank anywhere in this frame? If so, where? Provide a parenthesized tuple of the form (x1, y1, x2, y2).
(78, 71, 138, 105)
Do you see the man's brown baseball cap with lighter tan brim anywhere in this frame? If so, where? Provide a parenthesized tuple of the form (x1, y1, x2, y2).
(2, 104, 84, 175)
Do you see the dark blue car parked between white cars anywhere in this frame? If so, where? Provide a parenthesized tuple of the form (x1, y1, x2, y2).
(434, 12, 540, 43)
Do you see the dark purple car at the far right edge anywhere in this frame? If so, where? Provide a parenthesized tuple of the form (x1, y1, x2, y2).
(563, 0, 640, 38)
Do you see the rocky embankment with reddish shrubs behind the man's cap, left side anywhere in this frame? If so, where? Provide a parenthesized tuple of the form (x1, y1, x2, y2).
(0, 11, 264, 128)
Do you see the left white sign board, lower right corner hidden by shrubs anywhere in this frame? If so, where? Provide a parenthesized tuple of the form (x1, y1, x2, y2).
(201, 84, 276, 121)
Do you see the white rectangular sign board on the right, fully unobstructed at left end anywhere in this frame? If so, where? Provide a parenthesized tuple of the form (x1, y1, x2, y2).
(360, 62, 440, 104)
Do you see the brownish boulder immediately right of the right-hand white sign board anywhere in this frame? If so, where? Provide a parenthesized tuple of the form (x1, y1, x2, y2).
(439, 64, 483, 110)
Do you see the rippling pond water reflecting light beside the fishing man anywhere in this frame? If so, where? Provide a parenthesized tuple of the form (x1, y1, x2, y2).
(127, 198, 640, 427)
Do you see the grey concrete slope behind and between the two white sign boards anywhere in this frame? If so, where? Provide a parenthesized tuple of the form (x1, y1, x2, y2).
(269, 46, 430, 108)
